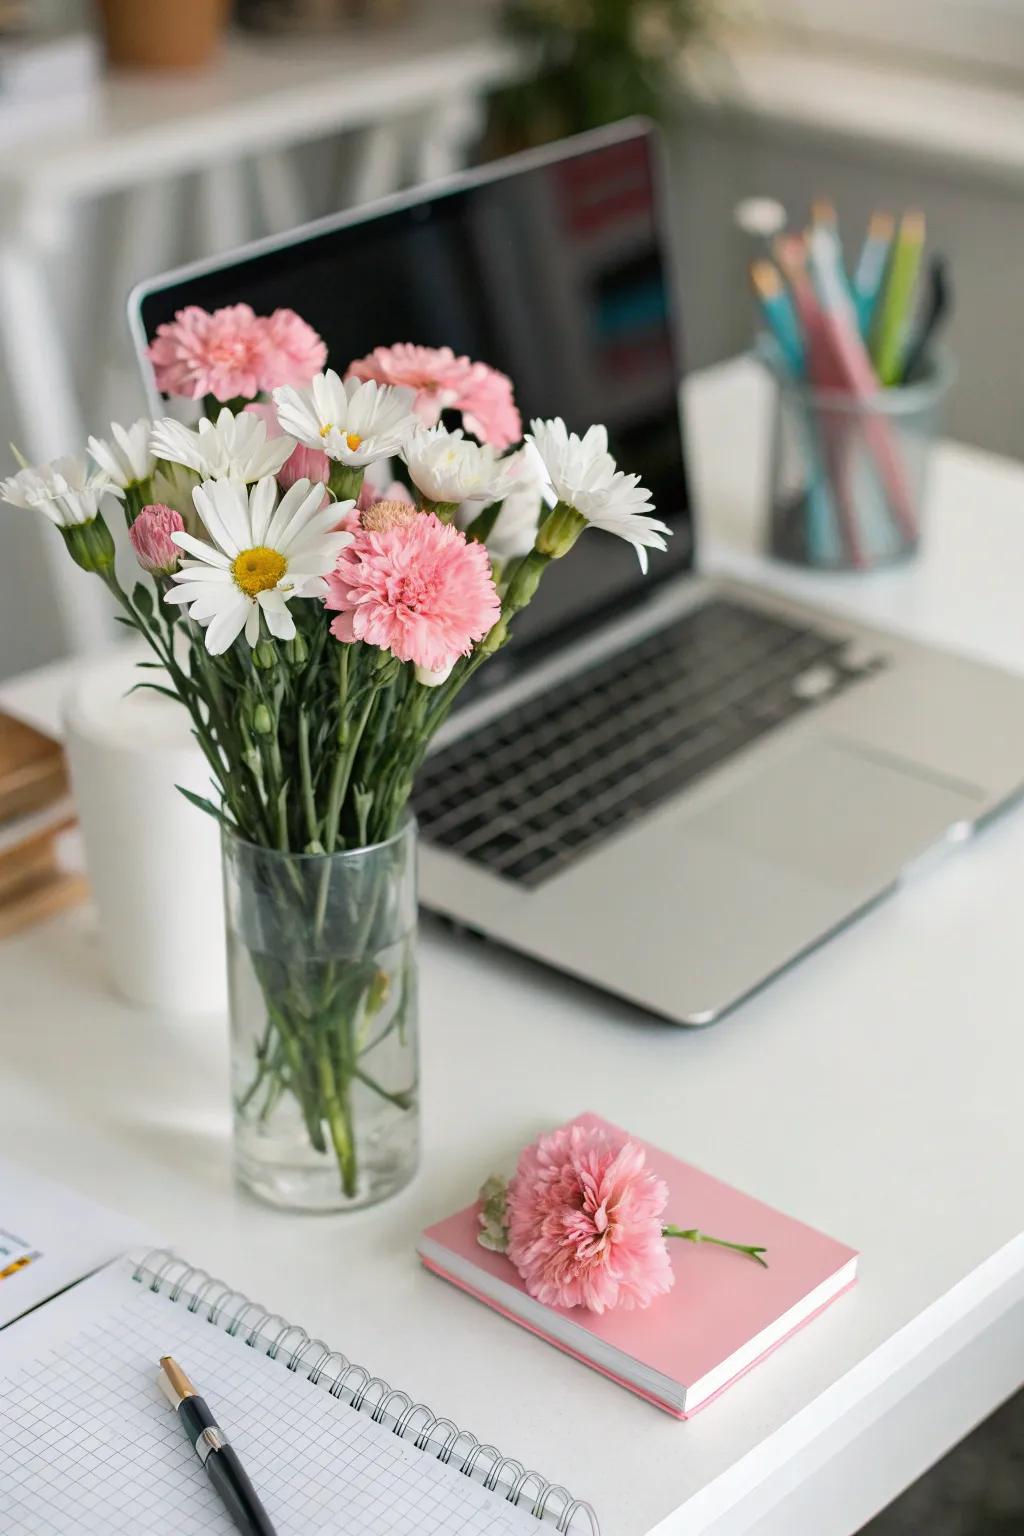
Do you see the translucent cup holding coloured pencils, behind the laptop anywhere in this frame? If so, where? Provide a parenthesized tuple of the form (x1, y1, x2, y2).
(761, 350, 953, 571)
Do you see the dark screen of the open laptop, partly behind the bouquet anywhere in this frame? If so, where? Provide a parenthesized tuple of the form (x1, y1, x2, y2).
(137, 129, 692, 682)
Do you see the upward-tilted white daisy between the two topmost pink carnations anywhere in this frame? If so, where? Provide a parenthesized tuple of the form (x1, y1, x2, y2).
(273, 369, 419, 468)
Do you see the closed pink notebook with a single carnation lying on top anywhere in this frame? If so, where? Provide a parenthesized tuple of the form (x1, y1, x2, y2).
(418, 1114, 857, 1418)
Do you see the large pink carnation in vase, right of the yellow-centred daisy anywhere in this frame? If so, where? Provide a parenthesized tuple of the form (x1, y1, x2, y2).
(327, 513, 500, 673)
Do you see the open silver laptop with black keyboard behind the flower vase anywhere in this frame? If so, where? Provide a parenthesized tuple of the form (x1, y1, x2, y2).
(129, 121, 1024, 1025)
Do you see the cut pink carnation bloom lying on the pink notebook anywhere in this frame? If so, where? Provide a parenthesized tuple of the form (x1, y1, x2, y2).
(507, 1124, 676, 1312)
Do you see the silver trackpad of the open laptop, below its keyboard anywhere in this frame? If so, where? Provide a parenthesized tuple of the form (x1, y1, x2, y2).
(688, 739, 984, 889)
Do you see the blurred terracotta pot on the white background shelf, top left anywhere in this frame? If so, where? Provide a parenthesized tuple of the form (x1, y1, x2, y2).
(100, 0, 230, 69)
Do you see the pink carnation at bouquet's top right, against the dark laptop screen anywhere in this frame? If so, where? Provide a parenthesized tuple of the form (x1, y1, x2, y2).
(348, 341, 522, 450)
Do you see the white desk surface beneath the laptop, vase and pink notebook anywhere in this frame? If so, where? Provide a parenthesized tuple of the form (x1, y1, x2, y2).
(0, 364, 1024, 1536)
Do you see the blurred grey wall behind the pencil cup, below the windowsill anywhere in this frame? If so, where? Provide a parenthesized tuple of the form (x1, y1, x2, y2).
(671, 103, 1024, 454)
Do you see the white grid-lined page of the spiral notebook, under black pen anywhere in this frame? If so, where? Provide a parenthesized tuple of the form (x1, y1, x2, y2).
(0, 1270, 539, 1536)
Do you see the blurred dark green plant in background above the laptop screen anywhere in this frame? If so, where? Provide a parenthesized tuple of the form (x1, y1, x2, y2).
(488, 0, 715, 152)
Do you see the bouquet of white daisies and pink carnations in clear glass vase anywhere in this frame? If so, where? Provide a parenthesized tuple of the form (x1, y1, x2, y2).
(0, 304, 668, 1209)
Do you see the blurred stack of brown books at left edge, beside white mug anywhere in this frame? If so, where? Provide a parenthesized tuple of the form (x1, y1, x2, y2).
(0, 713, 88, 938)
